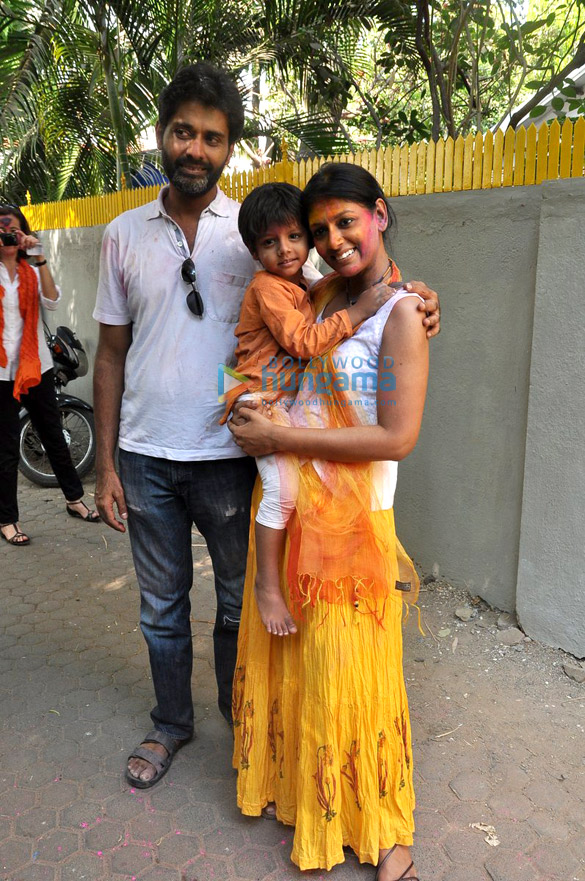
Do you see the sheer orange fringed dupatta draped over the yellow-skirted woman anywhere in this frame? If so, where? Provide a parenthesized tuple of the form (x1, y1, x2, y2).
(287, 263, 419, 622)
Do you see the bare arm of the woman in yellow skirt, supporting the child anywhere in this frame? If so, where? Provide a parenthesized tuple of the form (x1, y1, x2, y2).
(230, 297, 428, 462)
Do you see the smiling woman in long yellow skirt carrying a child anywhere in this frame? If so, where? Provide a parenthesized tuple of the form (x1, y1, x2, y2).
(232, 163, 428, 881)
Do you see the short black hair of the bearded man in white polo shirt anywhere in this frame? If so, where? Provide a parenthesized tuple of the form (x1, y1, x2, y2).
(158, 61, 244, 144)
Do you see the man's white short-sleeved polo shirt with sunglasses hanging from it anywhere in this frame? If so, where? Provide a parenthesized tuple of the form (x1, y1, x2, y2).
(93, 188, 318, 461)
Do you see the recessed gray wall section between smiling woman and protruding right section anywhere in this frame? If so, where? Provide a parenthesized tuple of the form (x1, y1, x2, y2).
(395, 187, 541, 609)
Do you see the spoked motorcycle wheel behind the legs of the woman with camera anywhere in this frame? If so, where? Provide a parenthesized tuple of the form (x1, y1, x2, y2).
(18, 404, 95, 486)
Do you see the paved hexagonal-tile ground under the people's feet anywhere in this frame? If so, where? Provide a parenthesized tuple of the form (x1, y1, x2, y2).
(0, 480, 585, 881)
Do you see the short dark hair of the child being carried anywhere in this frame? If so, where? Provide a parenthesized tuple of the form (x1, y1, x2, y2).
(238, 183, 312, 252)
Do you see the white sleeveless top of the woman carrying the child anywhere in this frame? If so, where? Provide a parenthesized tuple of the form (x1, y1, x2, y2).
(289, 289, 424, 511)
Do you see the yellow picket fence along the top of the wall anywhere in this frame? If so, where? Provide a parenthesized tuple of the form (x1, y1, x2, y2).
(23, 118, 585, 230)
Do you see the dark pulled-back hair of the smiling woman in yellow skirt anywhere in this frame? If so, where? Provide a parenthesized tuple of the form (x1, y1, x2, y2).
(301, 162, 396, 246)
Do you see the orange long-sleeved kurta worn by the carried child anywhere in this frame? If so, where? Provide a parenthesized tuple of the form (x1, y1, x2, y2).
(222, 271, 353, 421)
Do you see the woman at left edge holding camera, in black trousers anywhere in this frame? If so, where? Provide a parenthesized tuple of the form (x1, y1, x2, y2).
(0, 205, 99, 547)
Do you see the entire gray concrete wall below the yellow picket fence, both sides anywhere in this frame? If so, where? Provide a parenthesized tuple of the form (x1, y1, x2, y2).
(37, 180, 585, 655)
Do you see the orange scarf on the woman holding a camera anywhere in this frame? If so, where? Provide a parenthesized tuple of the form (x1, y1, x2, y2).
(0, 260, 41, 401)
